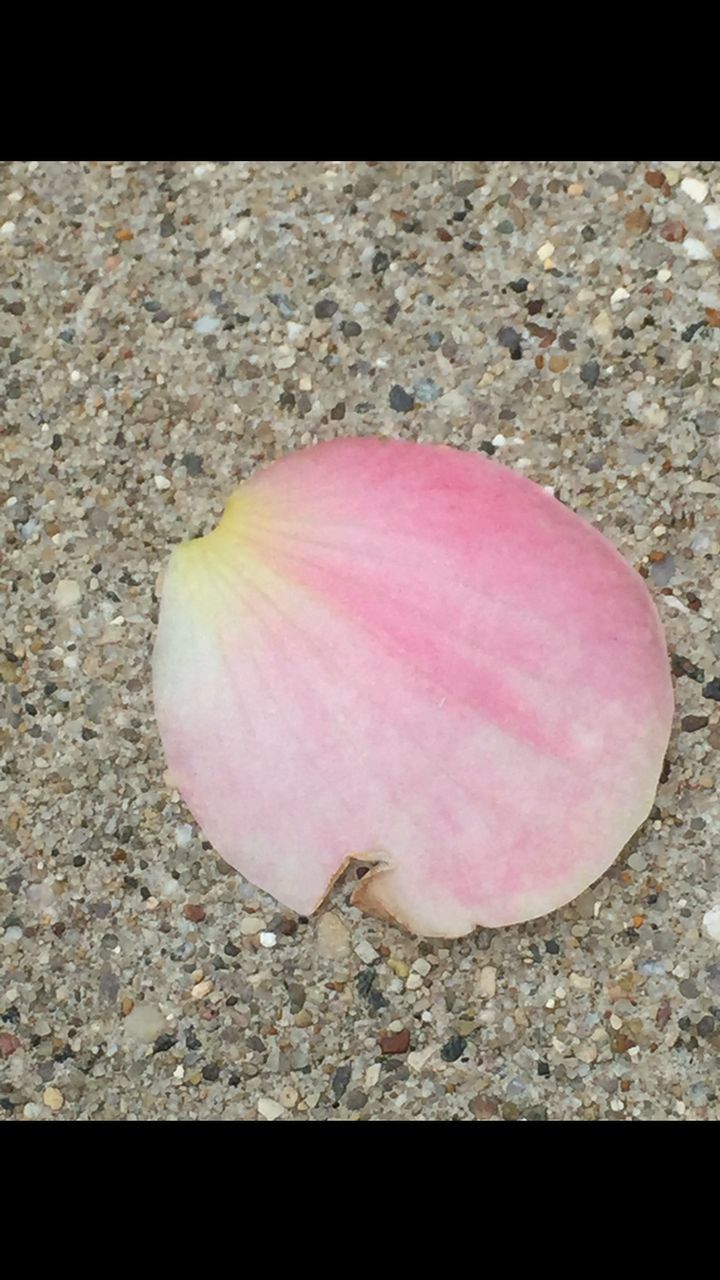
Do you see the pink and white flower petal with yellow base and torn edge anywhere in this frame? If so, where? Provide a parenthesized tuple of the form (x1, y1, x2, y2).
(154, 439, 673, 937)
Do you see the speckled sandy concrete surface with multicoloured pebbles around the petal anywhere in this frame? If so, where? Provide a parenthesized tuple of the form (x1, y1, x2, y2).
(0, 161, 720, 1120)
